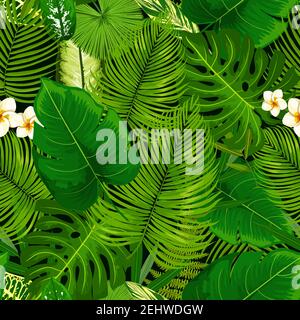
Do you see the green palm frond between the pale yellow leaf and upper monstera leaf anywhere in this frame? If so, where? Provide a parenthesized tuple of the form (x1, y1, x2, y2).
(98, 22, 184, 128)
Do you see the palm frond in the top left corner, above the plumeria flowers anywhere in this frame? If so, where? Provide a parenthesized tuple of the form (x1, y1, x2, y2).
(0, 0, 58, 104)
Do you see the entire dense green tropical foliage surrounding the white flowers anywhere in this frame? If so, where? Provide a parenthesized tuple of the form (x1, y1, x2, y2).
(0, 0, 300, 300)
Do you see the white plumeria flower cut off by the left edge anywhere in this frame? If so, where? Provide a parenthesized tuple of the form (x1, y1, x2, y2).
(0, 98, 19, 138)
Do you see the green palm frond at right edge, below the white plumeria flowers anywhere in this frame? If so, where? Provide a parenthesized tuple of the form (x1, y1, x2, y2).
(254, 126, 300, 223)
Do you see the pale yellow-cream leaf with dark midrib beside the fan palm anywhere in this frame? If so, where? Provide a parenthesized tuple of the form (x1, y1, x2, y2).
(59, 40, 100, 91)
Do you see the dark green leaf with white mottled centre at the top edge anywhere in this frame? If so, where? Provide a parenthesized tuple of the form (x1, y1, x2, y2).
(39, 0, 76, 40)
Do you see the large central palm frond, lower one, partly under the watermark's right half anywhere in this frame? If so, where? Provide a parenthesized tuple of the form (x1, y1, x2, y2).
(92, 100, 218, 270)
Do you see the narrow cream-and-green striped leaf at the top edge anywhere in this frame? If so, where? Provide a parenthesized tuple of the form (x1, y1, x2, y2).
(137, 0, 199, 32)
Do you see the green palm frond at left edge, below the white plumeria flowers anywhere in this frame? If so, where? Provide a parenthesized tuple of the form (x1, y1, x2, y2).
(0, 133, 51, 239)
